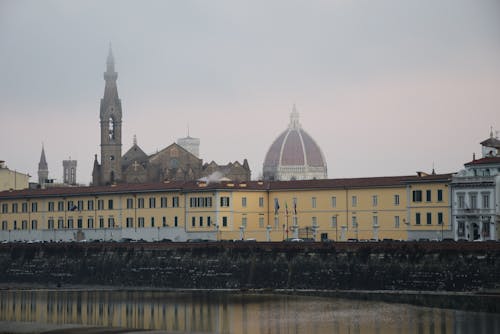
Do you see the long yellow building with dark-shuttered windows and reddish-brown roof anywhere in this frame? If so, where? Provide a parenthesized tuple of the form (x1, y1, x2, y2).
(0, 173, 452, 241)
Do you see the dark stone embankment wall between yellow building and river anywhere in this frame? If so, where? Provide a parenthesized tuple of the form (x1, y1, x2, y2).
(0, 242, 500, 292)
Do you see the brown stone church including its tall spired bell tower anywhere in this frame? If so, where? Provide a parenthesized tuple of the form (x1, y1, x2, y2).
(92, 48, 250, 185)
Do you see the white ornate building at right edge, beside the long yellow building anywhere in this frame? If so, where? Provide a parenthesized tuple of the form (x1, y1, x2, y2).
(451, 131, 500, 241)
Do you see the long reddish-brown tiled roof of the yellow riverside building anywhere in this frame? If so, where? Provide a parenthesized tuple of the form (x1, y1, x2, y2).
(0, 174, 452, 199)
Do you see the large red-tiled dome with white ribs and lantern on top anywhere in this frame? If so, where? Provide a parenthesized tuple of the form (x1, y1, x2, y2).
(264, 105, 327, 180)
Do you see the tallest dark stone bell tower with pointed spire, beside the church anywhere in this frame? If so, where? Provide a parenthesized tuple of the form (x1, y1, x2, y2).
(92, 45, 122, 185)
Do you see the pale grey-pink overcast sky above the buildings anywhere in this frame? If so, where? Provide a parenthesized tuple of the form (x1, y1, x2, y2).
(0, 0, 500, 184)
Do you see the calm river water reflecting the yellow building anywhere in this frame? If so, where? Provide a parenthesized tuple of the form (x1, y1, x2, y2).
(0, 290, 500, 334)
